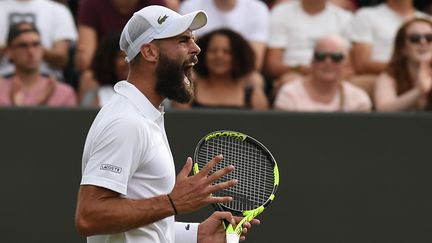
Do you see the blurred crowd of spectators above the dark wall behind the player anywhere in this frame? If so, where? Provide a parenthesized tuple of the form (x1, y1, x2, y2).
(0, 0, 432, 112)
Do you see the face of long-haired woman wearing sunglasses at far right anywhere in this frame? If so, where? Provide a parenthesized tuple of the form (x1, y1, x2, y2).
(404, 21, 432, 63)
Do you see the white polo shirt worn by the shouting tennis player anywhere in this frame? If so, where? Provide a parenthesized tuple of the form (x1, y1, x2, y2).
(81, 81, 198, 243)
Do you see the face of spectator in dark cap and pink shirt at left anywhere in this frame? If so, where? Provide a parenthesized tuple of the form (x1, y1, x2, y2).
(8, 32, 43, 73)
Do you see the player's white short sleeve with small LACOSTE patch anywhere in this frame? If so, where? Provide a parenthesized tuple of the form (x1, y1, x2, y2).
(81, 118, 149, 195)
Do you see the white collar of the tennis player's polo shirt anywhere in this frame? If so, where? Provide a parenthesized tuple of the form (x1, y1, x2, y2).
(114, 81, 164, 121)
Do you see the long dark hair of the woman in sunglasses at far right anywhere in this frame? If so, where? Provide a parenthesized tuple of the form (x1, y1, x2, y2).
(386, 17, 432, 106)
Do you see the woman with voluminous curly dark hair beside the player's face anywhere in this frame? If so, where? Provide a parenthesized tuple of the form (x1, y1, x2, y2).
(173, 29, 268, 110)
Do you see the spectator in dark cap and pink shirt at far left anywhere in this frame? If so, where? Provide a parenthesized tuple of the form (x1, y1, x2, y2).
(0, 22, 77, 106)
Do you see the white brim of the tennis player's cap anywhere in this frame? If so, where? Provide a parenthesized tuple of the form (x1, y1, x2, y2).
(155, 11, 207, 39)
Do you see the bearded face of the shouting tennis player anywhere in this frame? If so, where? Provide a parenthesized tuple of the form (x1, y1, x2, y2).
(156, 31, 200, 103)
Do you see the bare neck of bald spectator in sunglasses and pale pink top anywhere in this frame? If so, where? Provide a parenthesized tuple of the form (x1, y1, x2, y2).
(305, 78, 339, 103)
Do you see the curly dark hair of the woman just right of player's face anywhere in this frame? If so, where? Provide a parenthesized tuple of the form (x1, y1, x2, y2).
(195, 28, 255, 79)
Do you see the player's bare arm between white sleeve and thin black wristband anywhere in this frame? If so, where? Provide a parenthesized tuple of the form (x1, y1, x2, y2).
(76, 186, 174, 236)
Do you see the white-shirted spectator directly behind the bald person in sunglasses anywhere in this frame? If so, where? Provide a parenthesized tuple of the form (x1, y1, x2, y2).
(265, 0, 352, 96)
